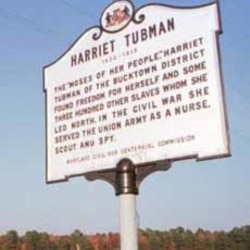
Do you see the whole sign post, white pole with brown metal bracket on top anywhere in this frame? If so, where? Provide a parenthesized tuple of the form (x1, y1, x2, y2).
(85, 158, 171, 250)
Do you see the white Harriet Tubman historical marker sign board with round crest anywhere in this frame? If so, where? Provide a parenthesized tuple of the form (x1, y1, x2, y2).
(44, 0, 230, 182)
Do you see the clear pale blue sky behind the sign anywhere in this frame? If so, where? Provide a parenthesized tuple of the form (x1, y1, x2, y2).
(0, 0, 250, 234)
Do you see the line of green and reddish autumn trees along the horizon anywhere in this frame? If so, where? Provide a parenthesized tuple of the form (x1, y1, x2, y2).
(0, 225, 250, 250)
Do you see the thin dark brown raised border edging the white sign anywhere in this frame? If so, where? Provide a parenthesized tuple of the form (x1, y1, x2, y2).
(43, 0, 231, 184)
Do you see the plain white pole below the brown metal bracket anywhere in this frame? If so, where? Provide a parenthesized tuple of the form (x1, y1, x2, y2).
(119, 194, 138, 250)
